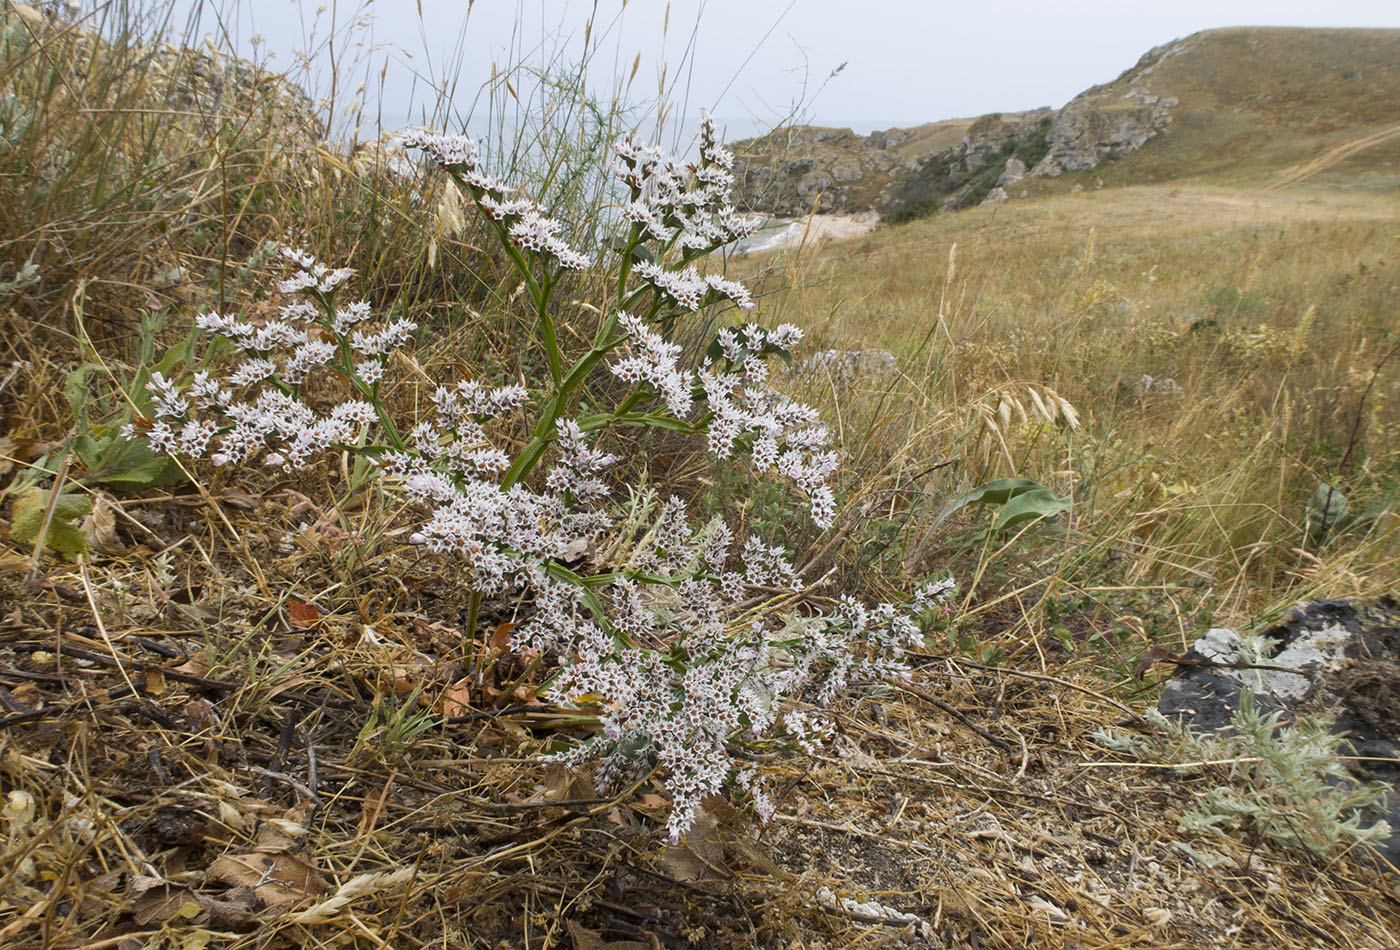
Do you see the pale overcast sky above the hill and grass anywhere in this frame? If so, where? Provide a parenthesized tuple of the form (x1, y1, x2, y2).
(183, 0, 1400, 136)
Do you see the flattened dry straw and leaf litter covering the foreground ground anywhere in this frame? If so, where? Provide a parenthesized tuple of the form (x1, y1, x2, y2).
(0, 523, 1400, 947)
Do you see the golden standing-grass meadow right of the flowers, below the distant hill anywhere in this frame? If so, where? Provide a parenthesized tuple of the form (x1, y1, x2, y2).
(756, 186, 1400, 643)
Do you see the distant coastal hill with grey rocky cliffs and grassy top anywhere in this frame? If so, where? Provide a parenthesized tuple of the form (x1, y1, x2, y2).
(739, 27, 1400, 217)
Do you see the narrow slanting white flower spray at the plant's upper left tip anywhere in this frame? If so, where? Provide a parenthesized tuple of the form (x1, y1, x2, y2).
(399, 130, 592, 270)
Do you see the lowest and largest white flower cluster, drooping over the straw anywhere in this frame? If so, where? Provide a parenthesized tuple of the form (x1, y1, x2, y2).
(529, 498, 948, 841)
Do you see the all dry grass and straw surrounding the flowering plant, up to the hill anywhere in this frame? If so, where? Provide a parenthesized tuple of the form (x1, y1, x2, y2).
(0, 3, 1400, 950)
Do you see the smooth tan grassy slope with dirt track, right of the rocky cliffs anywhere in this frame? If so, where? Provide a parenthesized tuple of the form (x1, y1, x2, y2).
(1030, 27, 1400, 190)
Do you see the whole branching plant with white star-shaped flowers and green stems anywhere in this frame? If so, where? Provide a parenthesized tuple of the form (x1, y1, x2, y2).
(129, 118, 951, 838)
